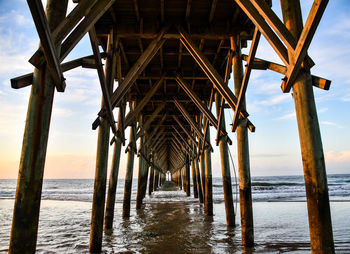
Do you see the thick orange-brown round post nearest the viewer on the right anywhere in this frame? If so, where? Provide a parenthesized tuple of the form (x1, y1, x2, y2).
(281, 0, 334, 253)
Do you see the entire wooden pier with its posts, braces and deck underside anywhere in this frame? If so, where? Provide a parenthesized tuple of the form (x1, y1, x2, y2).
(9, 0, 334, 253)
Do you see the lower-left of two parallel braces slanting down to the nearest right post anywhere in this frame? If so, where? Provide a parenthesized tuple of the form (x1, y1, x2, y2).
(235, 0, 289, 65)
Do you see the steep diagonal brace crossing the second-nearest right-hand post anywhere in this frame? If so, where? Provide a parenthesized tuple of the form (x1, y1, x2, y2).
(232, 28, 260, 132)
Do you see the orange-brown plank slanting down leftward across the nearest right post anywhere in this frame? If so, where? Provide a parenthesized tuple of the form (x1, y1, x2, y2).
(281, 0, 328, 93)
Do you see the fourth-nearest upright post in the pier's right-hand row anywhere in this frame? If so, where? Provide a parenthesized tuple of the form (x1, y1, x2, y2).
(204, 126, 213, 216)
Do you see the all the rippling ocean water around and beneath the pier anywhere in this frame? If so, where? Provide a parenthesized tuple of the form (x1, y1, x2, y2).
(0, 175, 350, 253)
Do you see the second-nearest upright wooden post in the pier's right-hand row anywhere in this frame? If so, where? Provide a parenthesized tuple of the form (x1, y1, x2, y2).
(231, 35, 254, 247)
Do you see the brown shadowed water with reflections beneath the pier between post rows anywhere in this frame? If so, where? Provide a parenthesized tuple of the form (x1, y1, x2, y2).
(105, 183, 240, 253)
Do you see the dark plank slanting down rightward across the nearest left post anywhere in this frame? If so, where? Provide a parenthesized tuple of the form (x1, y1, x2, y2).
(27, 0, 66, 92)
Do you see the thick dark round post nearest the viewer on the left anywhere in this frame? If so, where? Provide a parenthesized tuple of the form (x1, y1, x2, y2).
(9, 0, 68, 253)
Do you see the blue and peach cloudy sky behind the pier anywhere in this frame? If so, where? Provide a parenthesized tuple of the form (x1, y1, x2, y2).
(0, 0, 350, 178)
